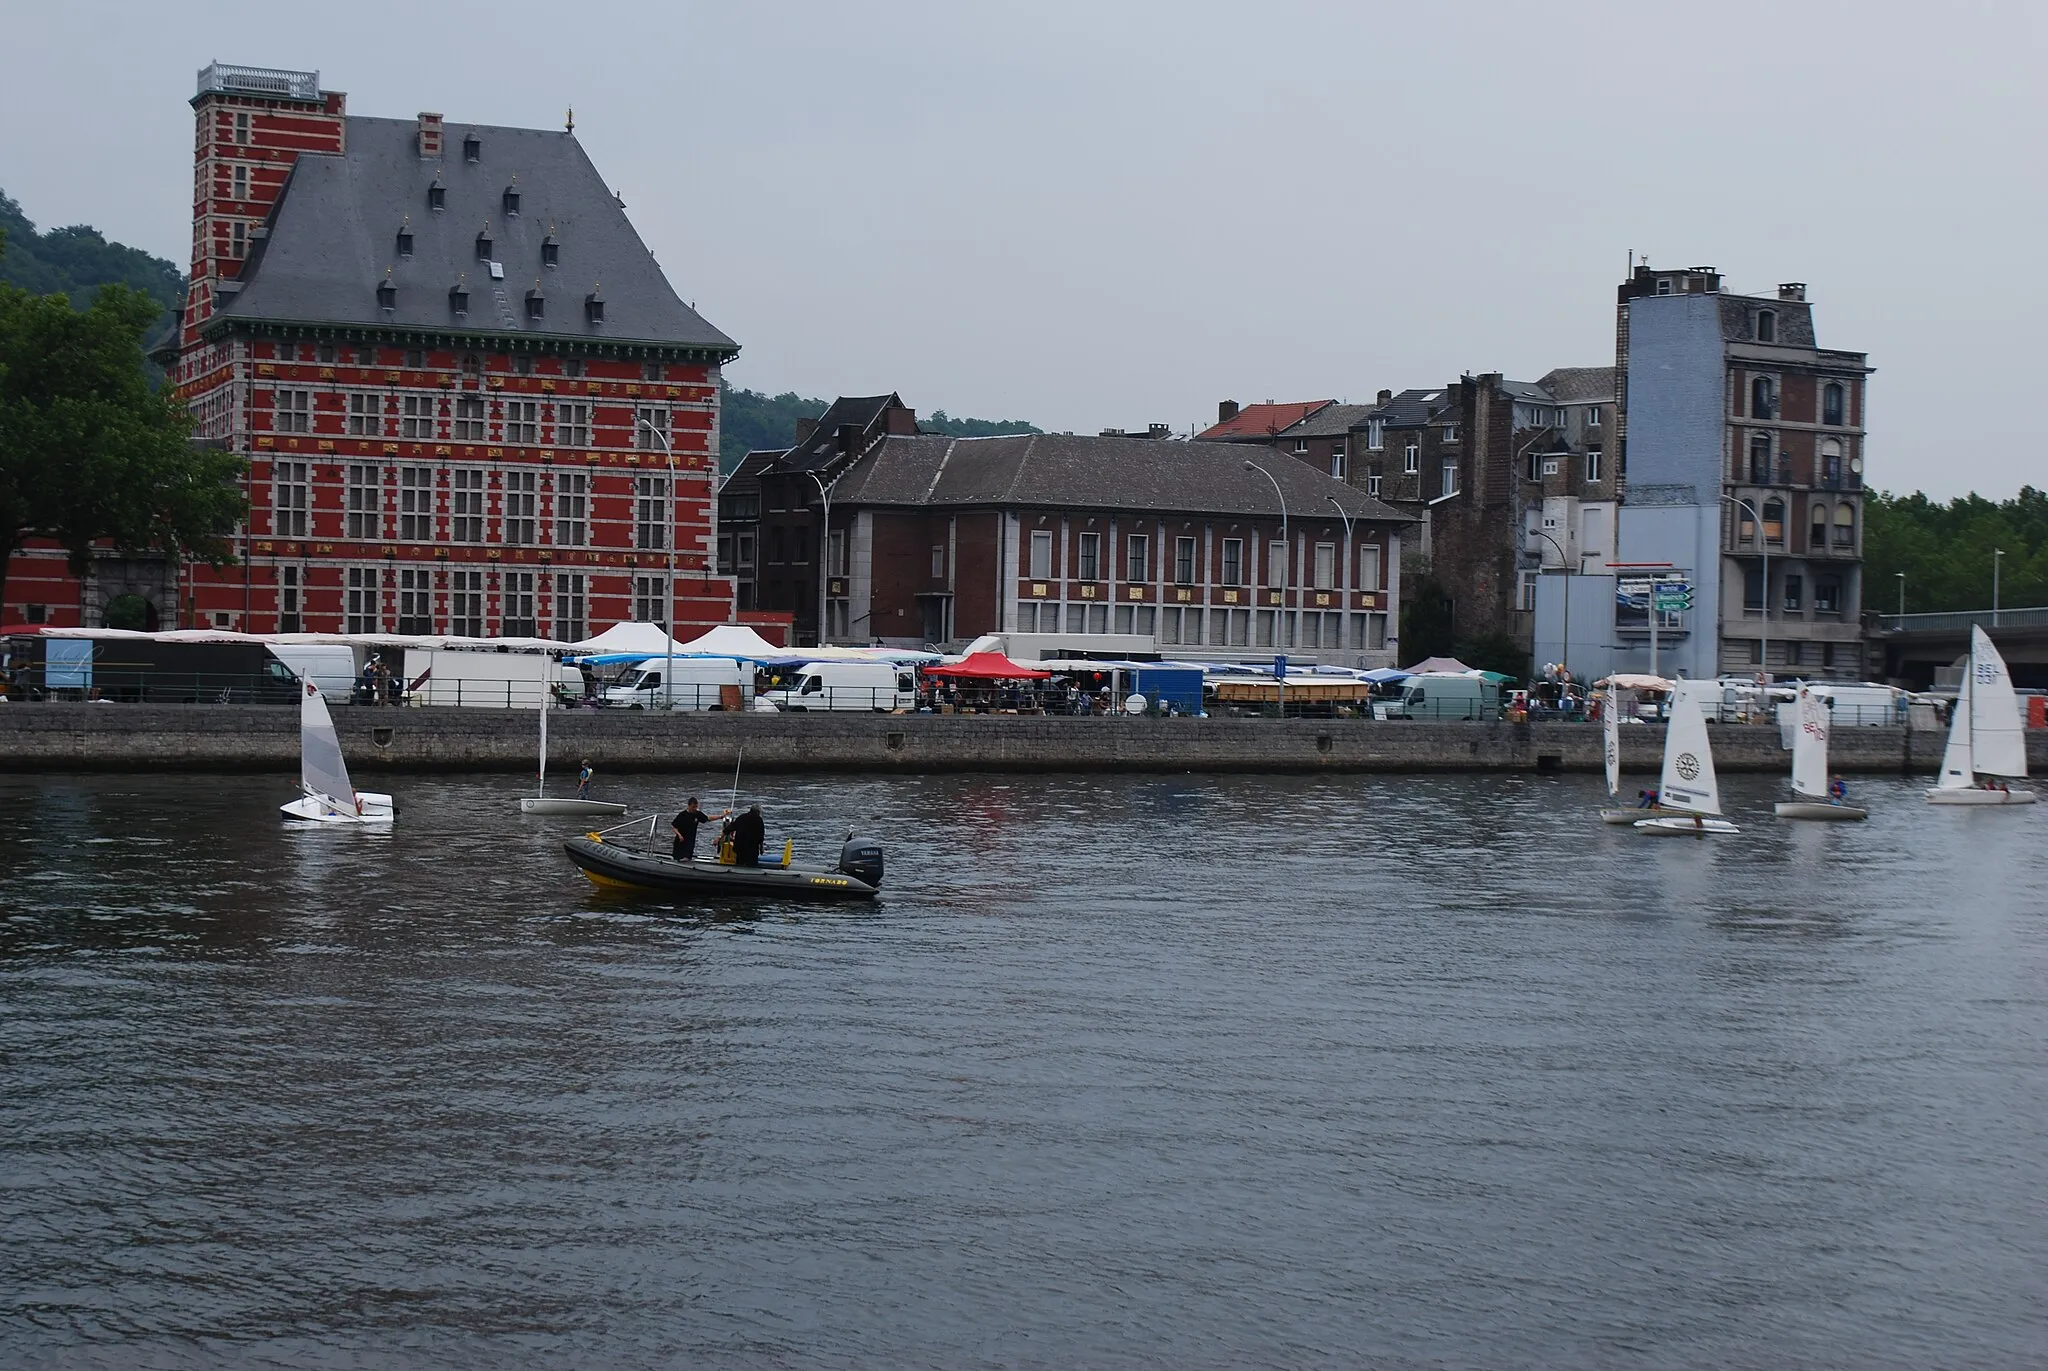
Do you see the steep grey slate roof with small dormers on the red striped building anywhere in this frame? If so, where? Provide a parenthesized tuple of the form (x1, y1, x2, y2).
(217, 117, 739, 355)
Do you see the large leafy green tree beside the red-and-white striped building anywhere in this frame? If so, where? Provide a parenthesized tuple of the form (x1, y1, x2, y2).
(0, 278, 246, 600)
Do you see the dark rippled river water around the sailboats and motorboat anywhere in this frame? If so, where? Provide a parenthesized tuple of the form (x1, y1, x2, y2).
(0, 775, 2048, 1367)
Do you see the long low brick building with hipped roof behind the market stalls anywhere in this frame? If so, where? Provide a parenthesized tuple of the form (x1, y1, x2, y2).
(806, 432, 1413, 666)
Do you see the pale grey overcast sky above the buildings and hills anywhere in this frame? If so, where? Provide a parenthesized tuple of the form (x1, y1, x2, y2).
(0, 0, 2048, 496)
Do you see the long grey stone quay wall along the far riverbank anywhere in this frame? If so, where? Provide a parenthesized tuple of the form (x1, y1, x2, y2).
(0, 703, 2048, 775)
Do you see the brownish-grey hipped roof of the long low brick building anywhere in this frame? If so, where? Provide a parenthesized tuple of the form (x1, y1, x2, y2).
(834, 432, 1411, 523)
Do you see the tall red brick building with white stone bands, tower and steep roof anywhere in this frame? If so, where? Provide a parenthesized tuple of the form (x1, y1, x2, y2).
(6, 64, 739, 639)
